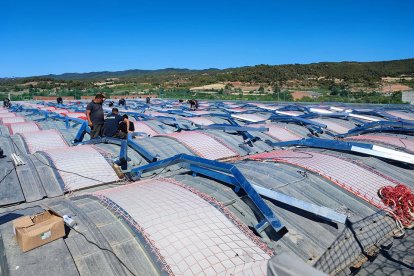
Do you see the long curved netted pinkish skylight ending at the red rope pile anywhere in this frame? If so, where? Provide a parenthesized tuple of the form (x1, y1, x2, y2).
(250, 150, 404, 208)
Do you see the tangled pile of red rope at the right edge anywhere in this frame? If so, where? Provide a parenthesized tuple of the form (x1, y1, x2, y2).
(378, 184, 414, 227)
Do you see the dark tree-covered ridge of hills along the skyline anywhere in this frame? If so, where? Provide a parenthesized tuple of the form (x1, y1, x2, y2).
(32, 58, 414, 83)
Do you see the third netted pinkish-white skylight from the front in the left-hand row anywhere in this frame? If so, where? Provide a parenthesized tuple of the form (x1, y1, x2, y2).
(20, 129, 69, 153)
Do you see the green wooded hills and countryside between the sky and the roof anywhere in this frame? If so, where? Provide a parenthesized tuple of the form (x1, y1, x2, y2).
(0, 59, 414, 103)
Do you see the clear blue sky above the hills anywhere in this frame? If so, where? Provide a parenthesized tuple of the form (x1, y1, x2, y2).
(0, 0, 414, 77)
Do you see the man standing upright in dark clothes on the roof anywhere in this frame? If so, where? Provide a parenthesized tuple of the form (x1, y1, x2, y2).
(86, 94, 106, 139)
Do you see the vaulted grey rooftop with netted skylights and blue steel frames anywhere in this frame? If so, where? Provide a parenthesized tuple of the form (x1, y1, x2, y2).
(0, 99, 414, 275)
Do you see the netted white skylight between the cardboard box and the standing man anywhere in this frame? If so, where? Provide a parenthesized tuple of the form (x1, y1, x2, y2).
(43, 145, 118, 192)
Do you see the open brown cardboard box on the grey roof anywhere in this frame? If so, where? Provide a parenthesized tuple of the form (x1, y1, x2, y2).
(13, 210, 65, 252)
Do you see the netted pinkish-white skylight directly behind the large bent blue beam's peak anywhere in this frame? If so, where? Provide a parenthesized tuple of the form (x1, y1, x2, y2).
(159, 131, 238, 160)
